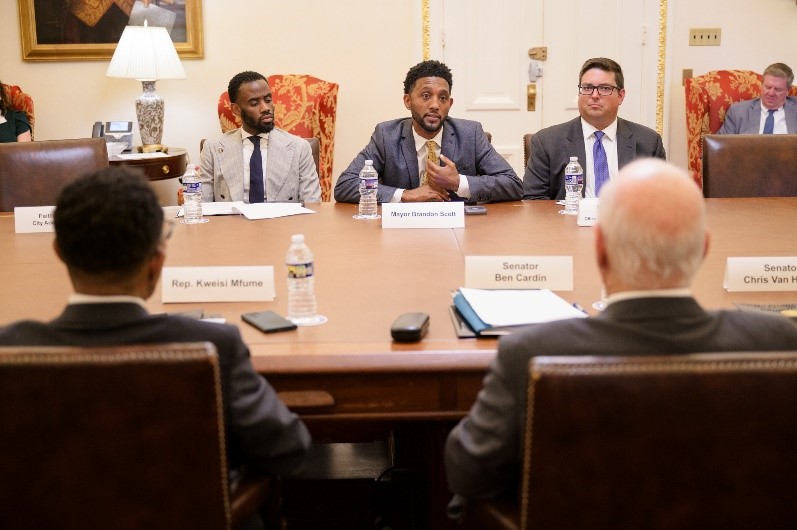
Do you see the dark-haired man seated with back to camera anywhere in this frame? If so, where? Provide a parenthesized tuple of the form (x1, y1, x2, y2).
(0, 166, 311, 524)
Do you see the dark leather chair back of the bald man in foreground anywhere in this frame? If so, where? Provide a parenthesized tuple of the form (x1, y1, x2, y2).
(521, 351, 797, 528)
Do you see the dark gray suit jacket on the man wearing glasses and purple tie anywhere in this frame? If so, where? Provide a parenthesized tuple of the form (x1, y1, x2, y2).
(523, 117, 666, 200)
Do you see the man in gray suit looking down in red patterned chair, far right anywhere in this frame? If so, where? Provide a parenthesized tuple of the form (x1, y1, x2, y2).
(718, 63, 797, 134)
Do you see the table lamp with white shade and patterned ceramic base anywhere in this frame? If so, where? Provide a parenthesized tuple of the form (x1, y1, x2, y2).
(105, 23, 185, 153)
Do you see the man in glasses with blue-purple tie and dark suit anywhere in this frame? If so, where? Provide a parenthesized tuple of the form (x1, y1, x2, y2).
(523, 57, 665, 200)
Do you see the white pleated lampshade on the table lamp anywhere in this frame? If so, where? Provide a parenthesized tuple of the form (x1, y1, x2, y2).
(105, 26, 185, 81)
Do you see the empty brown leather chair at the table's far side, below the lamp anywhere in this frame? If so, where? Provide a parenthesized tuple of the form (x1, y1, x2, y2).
(0, 138, 108, 212)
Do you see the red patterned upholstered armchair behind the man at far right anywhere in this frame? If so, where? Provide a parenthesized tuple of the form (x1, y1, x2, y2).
(684, 70, 797, 186)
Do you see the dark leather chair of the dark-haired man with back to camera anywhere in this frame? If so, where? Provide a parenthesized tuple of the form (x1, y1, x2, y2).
(0, 343, 270, 529)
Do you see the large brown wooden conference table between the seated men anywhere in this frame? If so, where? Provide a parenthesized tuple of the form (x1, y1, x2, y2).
(0, 198, 797, 524)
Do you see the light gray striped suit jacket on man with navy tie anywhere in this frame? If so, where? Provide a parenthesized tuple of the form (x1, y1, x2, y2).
(199, 128, 321, 202)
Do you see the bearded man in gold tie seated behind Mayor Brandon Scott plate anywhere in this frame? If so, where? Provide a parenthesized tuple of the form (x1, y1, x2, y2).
(335, 61, 523, 203)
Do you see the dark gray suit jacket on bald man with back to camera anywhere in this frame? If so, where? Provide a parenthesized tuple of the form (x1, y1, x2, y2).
(445, 297, 797, 498)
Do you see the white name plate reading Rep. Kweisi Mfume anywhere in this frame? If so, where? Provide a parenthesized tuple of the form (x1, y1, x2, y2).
(161, 266, 274, 304)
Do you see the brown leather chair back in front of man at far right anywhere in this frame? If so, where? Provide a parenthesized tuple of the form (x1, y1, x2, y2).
(703, 134, 797, 197)
